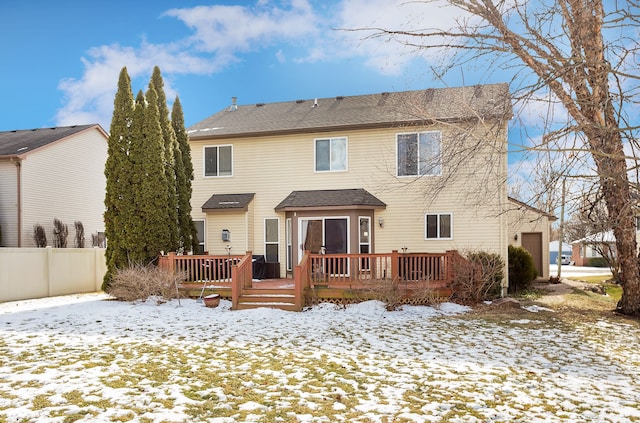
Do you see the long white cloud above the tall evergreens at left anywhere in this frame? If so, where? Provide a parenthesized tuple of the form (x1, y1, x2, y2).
(56, 0, 316, 130)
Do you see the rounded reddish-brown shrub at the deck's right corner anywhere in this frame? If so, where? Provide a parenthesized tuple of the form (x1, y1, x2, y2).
(452, 251, 504, 304)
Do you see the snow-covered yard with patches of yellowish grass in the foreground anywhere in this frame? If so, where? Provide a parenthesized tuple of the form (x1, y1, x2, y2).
(0, 294, 640, 422)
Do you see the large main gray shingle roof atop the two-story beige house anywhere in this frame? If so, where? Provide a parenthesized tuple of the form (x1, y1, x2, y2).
(188, 83, 511, 139)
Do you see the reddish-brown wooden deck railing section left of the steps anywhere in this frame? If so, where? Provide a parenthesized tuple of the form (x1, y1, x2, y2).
(158, 253, 242, 283)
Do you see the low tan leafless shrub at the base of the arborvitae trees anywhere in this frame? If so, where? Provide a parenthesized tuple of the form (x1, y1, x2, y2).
(108, 264, 186, 301)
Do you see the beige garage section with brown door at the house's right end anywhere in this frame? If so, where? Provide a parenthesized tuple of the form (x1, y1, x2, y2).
(508, 197, 557, 278)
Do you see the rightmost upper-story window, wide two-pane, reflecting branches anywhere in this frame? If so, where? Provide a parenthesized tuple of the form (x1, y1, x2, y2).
(397, 131, 442, 176)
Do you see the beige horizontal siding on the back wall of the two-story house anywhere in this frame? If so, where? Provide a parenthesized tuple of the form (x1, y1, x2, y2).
(190, 127, 507, 274)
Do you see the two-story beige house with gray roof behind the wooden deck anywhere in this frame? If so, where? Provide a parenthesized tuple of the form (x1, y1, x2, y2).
(188, 84, 512, 284)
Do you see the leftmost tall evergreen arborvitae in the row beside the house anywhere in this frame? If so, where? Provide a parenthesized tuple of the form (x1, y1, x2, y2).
(102, 67, 134, 291)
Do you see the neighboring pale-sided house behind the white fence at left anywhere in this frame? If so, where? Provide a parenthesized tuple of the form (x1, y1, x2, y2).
(0, 124, 107, 247)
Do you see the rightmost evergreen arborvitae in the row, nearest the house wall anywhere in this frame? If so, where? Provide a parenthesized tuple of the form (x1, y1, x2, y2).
(171, 96, 198, 251)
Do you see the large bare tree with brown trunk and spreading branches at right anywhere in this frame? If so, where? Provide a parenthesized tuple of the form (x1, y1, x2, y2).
(354, 0, 640, 316)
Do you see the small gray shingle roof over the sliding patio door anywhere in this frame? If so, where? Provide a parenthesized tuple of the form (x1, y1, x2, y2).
(275, 188, 387, 211)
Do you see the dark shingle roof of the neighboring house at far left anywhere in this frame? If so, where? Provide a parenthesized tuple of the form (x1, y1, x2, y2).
(0, 124, 98, 157)
